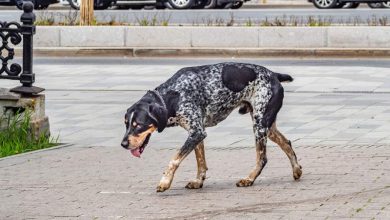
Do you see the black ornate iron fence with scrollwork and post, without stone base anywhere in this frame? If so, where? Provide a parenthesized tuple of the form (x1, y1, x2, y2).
(0, 1, 44, 95)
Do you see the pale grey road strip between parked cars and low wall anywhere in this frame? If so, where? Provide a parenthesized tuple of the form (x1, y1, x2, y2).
(0, 8, 390, 26)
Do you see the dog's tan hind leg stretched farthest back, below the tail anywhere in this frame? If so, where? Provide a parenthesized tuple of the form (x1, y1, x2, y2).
(268, 122, 302, 180)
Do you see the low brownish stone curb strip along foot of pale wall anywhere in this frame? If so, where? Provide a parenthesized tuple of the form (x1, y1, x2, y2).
(26, 47, 390, 58)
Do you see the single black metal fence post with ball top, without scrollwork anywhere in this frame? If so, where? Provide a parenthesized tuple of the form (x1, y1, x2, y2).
(11, 1, 45, 95)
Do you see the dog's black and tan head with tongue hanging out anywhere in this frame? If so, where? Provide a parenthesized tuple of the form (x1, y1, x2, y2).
(121, 99, 168, 157)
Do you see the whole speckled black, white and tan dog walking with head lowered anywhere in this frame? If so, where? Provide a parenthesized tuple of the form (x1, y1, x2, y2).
(121, 62, 302, 192)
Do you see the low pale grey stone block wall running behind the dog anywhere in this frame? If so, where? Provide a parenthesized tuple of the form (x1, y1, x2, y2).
(34, 26, 390, 51)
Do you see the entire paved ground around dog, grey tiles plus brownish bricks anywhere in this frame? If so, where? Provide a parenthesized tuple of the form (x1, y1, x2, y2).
(0, 58, 390, 219)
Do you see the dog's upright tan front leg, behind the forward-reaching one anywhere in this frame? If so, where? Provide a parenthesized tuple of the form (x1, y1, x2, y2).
(186, 141, 207, 189)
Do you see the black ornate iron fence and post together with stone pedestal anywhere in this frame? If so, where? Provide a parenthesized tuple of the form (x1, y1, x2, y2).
(0, 1, 50, 139)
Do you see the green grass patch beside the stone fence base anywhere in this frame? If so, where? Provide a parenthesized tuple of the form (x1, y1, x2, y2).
(0, 110, 58, 158)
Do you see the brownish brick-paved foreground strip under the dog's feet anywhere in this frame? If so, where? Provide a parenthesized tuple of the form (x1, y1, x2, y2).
(0, 143, 390, 219)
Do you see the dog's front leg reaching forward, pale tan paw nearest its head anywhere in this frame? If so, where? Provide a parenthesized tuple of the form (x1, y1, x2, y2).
(157, 131, 206, 192)
